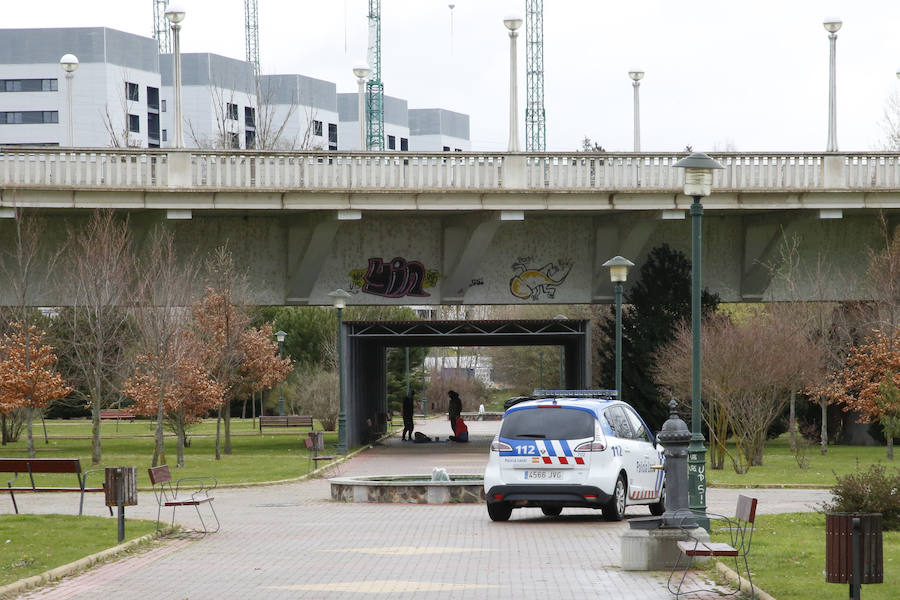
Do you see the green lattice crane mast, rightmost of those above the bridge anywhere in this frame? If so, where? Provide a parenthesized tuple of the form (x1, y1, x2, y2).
(525, 0, 547, 152)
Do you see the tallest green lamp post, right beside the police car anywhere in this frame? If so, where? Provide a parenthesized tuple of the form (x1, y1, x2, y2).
(674, 152, 724, 514)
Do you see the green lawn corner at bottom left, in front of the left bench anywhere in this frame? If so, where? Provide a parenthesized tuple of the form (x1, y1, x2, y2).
(0, 515, 156, 586)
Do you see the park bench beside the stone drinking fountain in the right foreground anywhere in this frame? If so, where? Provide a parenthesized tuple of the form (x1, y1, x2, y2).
(667, 495, 758, 598)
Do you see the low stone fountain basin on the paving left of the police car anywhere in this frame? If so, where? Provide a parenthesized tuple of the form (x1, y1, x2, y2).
(328, 475, 484, 504)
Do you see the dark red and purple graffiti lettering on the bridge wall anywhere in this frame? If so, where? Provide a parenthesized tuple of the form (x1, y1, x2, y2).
(349, 256, 441, 298)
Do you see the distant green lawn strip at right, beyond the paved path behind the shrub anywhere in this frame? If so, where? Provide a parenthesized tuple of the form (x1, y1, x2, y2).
(706, 435, 900, 487)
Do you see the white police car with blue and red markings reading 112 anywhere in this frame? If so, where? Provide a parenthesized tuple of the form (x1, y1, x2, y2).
(484, 390, 665, 521)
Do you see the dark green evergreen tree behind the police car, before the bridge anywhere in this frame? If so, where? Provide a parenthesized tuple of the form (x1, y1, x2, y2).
(598, 244, 719, 431)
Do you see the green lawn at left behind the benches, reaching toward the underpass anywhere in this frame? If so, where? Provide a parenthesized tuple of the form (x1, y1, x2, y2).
(0, 419, 337, 488)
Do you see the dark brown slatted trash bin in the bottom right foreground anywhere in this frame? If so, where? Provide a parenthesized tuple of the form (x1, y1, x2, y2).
(825, 513, 884, 584)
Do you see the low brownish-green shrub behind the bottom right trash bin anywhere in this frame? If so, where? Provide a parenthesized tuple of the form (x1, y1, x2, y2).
(823, 463, 900, 531)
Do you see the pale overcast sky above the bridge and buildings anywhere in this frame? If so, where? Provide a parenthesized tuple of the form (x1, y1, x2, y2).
(7, 0, 900, 151)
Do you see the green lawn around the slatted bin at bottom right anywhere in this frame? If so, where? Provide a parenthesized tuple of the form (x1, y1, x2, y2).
(713, 513, 900, 600)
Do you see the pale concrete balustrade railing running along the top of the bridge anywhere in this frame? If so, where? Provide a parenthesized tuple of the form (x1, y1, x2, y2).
(0, 147, 900, 192)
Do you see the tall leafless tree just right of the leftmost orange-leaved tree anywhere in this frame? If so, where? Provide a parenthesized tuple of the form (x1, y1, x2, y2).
(60, 211, 136, 465)
